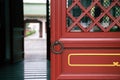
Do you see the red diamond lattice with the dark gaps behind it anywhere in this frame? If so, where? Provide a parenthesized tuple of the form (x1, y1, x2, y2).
(66, 0, 120, 32)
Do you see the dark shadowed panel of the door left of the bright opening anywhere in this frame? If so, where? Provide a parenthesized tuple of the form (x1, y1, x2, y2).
(12, 28, 24, 63)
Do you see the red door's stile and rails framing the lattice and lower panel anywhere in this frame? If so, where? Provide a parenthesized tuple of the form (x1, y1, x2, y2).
(50, 0, 120, 80)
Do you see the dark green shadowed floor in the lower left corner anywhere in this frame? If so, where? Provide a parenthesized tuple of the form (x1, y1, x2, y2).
(0, 62, 24, 80)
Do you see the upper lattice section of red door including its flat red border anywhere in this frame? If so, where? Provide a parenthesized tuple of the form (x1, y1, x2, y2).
(61, 0, 120, 38)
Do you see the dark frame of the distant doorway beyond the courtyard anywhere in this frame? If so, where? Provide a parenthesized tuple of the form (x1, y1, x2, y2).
(24, 19, 43, 38)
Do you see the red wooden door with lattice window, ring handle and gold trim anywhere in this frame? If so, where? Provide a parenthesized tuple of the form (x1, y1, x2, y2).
(51, 0, 120, 80)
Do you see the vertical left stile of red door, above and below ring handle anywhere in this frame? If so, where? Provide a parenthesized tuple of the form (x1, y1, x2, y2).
(51, 0, 62, 80)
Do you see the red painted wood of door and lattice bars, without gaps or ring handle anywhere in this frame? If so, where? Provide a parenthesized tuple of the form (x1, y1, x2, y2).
(50, 0, 120, 80)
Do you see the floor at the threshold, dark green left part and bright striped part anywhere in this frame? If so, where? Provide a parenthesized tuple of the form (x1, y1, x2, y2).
(0, 61, 47, 80)
